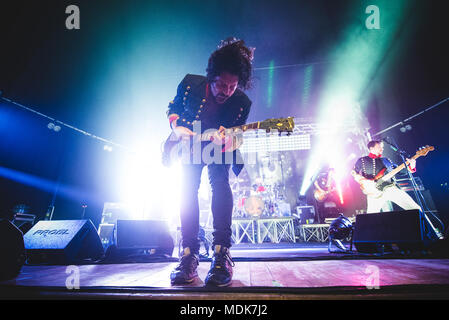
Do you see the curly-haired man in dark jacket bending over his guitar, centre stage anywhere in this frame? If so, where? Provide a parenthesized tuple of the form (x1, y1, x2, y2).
(167, 38, 254, 287)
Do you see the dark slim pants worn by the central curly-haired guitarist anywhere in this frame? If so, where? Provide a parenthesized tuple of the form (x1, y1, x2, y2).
(181, 164, 233, 253)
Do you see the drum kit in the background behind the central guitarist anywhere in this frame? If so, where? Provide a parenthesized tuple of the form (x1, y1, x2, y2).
(231, 179, 290, 218)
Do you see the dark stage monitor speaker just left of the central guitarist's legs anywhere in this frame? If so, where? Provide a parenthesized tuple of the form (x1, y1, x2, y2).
(116, 220, 174, 256)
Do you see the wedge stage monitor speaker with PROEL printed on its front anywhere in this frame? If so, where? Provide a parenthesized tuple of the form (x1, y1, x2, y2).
(24, 220, 104, 264)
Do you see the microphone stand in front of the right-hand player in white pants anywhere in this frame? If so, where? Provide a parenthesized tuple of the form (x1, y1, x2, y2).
(382, 139, 444, 240)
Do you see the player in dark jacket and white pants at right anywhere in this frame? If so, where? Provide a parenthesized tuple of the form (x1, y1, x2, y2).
(352, 140, 421, 213)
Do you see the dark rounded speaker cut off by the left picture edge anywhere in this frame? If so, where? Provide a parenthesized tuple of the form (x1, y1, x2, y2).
(0, 219, 26, 280)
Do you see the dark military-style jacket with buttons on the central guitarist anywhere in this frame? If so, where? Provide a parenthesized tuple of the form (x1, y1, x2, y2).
(167, 74, 251, 175)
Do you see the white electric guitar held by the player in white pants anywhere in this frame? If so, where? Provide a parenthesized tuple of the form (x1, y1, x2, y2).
(351, 146, 435, 198)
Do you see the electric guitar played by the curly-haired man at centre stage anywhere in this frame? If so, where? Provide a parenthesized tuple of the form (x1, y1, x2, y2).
(162, 117, 295, 167)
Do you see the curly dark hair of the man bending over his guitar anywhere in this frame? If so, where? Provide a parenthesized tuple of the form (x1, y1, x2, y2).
(206, 38, 255, 89)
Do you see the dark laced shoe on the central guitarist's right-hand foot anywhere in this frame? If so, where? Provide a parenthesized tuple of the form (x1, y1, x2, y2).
(204, 245, 234, 287)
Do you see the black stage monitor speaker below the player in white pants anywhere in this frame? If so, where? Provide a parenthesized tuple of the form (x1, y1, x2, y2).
(353, 210, 431, 253)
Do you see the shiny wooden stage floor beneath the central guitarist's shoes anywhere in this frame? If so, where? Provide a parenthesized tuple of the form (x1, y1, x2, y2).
(0, 244, 449, 300)
